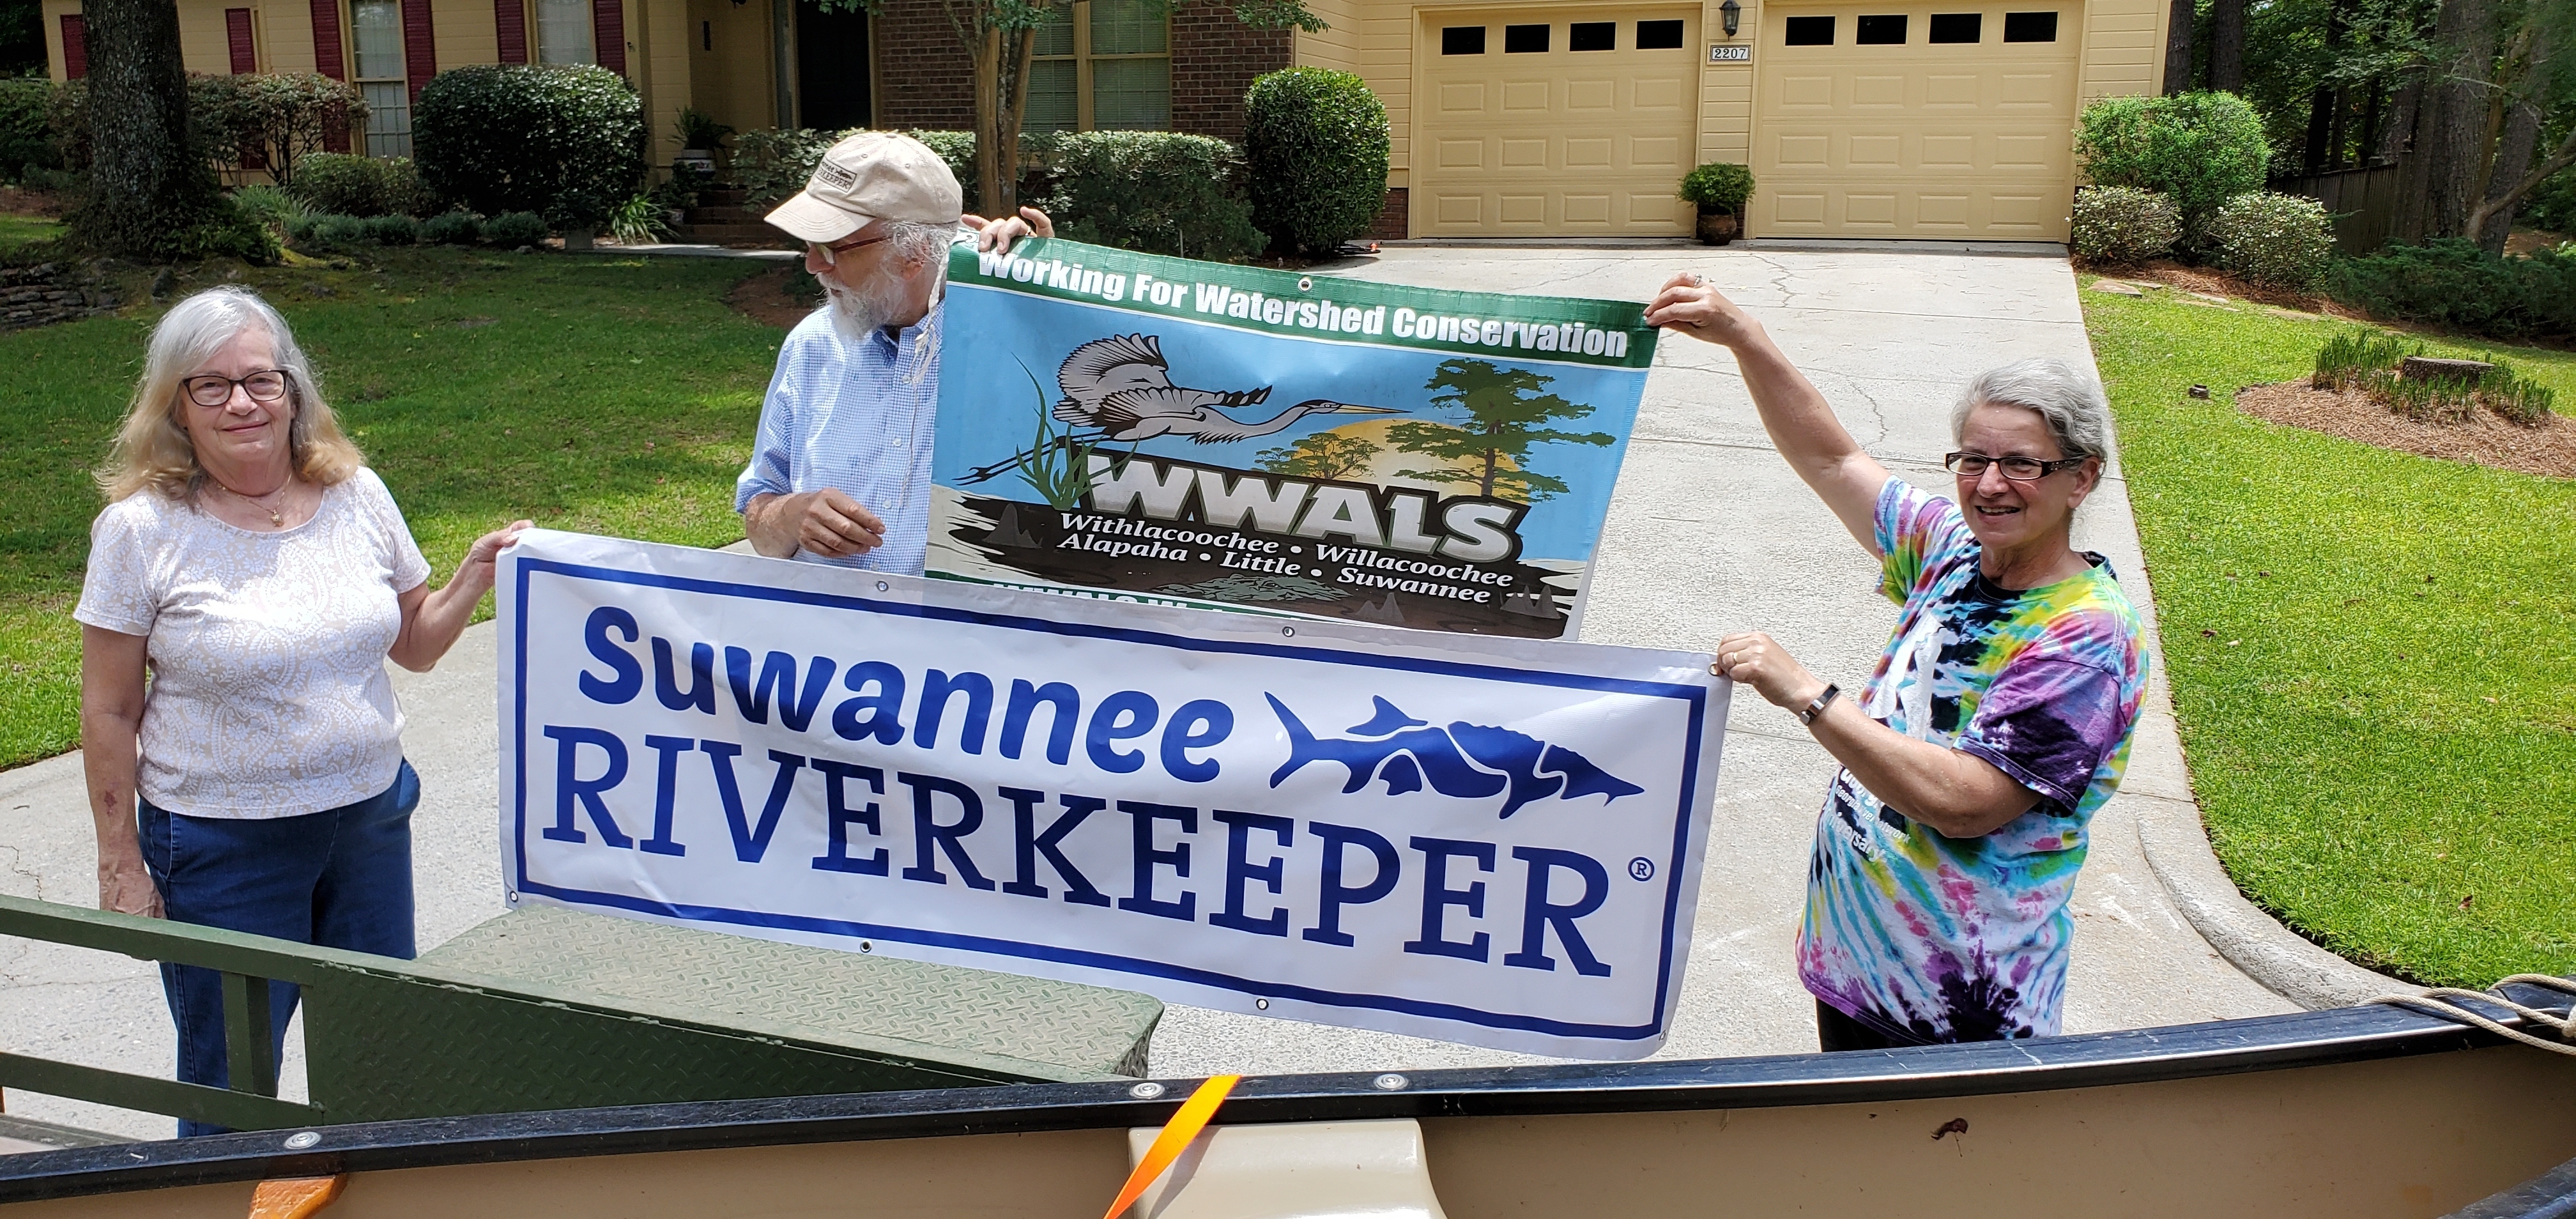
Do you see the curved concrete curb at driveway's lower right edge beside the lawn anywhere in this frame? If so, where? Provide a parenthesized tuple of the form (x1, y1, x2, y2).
(2136, 778, 2424, 1010)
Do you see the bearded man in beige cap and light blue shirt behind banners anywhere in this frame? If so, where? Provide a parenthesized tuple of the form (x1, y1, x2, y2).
(734, 132, 1054, 575)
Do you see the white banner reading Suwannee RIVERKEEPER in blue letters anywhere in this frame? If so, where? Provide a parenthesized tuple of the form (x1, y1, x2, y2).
(500, 531, 1726, 1057)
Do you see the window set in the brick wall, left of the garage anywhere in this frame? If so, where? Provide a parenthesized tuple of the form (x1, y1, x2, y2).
(1020, 0, 1172, 132)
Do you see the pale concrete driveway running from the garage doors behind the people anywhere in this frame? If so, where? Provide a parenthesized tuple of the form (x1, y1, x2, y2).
(0, 245, 2296, 1137)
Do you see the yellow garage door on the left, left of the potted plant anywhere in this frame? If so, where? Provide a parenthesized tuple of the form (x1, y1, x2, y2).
(1412, 8, 1700, 237)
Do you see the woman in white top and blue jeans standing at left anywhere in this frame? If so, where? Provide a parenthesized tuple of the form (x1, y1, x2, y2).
(72, 289, 528, 1134)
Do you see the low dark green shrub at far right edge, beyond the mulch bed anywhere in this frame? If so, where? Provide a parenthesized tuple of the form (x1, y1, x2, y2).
(2321, 237, 2576, 337)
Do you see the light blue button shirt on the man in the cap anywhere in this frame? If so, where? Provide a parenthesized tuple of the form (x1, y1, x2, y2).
(734, 304, 946, 575)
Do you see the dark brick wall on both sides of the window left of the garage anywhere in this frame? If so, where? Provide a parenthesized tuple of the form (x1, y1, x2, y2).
(873, 0, 1291, 139)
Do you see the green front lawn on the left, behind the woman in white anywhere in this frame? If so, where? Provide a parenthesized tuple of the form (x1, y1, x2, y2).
(0, 247, 781, 768)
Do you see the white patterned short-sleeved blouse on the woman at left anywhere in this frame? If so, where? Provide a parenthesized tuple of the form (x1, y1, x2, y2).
(72, 469, 430, 820)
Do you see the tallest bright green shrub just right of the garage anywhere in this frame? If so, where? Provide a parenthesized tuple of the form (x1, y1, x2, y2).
(2076, 93, 2272, 250)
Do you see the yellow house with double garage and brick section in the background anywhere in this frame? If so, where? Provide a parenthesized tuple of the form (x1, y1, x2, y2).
(44, 0, 2169, 242)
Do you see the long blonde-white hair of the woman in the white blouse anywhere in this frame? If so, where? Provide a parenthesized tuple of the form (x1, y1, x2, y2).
(98, 284, 366, 503)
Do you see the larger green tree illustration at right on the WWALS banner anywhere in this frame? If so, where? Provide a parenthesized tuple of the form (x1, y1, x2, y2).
(1386, 361, 1615, 503)
